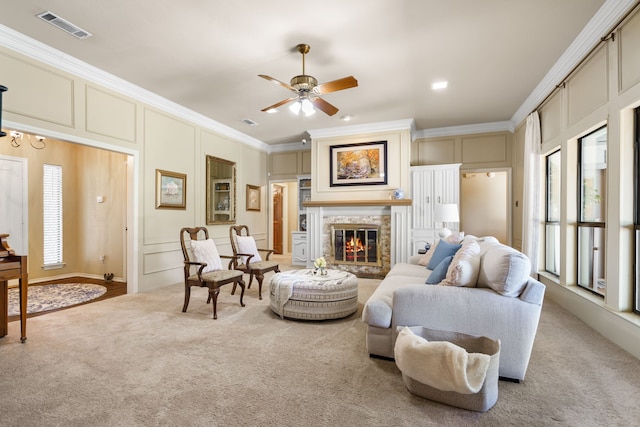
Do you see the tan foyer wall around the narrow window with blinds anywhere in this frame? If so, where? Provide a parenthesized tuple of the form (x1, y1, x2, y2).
(0, 135, 126, 281)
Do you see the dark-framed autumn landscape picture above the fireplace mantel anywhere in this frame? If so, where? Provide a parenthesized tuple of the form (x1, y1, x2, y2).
(329, 141, 387, 187)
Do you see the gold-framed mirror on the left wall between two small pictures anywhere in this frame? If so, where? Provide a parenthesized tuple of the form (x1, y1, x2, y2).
(206, 155, 236, 225)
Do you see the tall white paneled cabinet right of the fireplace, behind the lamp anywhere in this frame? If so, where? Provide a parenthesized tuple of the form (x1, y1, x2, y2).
(411, 163, 460, 254)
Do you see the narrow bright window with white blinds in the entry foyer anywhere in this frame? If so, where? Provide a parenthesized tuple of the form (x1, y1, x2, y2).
(42, 164, 62, 269)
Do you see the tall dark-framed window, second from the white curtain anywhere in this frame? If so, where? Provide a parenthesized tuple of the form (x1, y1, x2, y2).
(578, 126, 607, 295)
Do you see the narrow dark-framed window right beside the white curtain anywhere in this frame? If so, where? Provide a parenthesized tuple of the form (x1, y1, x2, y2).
(545, 150, 561, 276)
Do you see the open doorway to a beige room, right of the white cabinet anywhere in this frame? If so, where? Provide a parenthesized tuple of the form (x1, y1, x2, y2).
(460, 168, 511, 245)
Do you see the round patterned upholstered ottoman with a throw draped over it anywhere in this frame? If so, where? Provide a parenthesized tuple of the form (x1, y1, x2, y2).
(269, 269, 358, 320)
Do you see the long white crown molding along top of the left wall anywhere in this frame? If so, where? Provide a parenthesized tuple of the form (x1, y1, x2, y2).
(0, 24, 269, 152)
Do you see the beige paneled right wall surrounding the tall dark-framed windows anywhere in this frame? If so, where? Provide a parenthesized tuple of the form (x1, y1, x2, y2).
(516, 6, 640, 357)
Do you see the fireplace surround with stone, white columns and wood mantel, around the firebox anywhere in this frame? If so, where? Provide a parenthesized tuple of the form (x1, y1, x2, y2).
(304, 199, 411, 277)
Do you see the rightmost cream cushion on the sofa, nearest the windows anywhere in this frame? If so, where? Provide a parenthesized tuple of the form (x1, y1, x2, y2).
(478, 244, 531, 297)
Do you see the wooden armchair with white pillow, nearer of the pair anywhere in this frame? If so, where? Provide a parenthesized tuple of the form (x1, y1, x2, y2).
(180, 227, 244, 319)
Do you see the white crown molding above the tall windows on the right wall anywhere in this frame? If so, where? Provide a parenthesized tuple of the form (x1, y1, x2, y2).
(511, 0, 638, 127)
